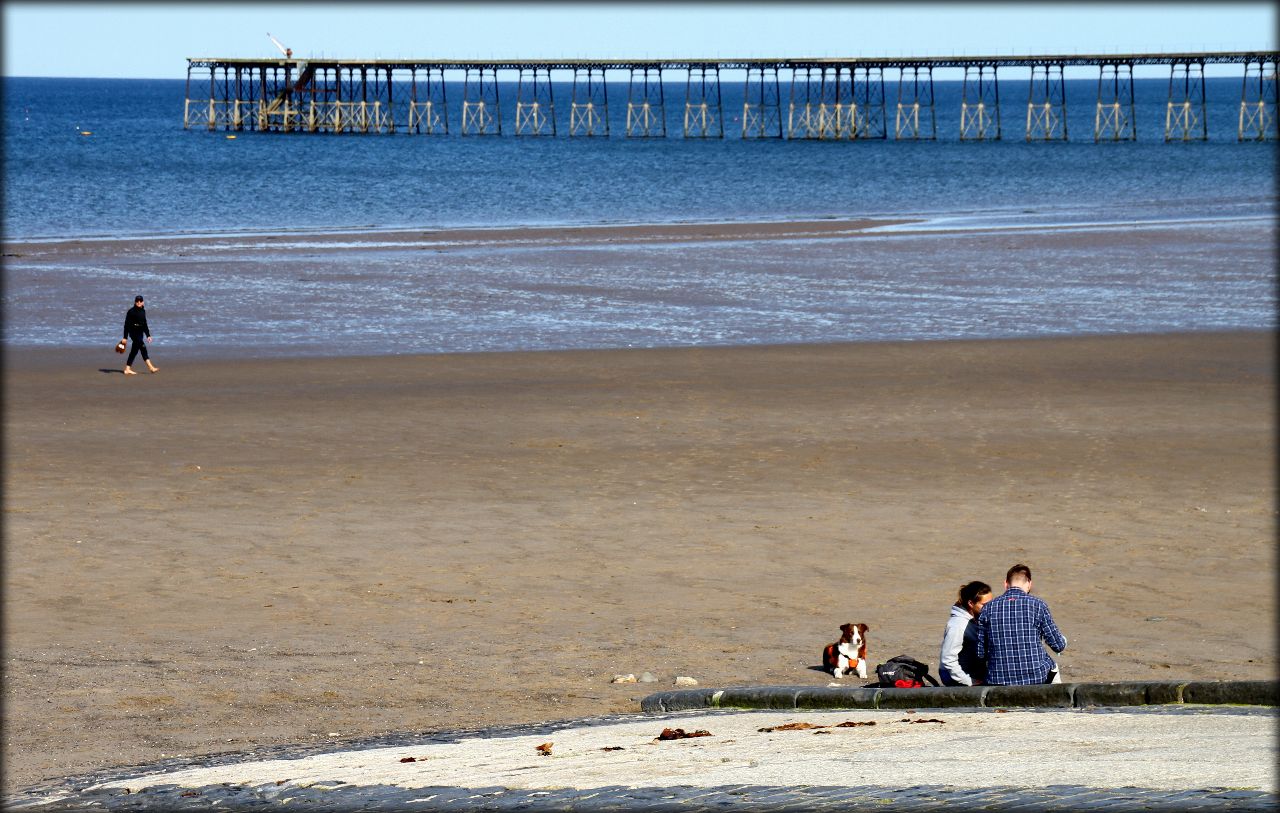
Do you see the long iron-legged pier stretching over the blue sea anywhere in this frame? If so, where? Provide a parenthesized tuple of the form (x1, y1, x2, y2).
(183, 51, 1280, 142)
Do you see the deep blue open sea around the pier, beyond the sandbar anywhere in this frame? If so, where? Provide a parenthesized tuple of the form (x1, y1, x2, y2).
(4, 78, 1276, 238)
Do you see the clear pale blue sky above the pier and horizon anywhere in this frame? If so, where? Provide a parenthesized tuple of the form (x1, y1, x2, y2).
(3, 0, 1276, 79)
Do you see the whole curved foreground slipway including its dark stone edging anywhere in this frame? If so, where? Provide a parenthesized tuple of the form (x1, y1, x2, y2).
(5, 681, 1280, 812)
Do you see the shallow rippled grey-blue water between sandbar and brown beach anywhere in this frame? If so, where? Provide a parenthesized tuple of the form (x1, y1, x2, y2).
(4, 218, 1276, 357)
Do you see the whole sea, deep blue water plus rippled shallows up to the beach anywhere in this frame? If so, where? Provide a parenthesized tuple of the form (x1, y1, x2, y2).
(3, 77, 1277, 355)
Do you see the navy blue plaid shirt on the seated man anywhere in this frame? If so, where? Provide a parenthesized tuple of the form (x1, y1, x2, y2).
(978, 588, 1066, 686)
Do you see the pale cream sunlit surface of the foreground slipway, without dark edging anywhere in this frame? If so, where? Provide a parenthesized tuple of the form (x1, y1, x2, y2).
(50, 711, 1277, 800)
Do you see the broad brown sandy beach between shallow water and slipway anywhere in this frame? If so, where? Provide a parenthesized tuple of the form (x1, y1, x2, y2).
(4, 332, 1276, 791)
